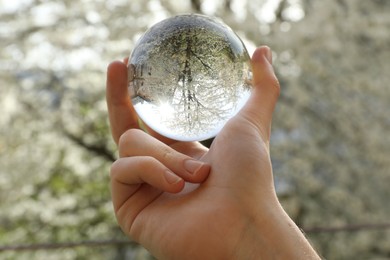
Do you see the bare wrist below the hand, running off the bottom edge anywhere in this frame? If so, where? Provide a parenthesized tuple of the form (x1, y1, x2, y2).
(236, 196, 320, 259)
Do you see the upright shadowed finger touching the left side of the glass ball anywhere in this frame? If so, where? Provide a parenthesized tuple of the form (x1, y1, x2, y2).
(106, 61, 139, 144)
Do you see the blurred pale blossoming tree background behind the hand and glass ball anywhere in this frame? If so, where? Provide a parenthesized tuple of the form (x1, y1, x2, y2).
(0, 0, 390, 260)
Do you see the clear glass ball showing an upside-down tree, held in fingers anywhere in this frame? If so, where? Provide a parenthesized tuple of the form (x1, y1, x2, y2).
(128, 14, 251, 141)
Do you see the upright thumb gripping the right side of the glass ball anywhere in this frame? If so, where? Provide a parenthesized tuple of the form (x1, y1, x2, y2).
(240, 46, 280, 141)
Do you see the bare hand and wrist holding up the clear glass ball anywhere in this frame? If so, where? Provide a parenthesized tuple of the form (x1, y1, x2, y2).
(107, 46, 319, 259)
